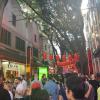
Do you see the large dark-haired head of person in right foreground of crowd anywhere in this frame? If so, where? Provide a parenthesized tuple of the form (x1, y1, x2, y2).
(66, 76, 87, 100)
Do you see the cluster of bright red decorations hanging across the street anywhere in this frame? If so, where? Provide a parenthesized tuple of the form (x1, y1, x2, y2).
(43, 52, 80, 70)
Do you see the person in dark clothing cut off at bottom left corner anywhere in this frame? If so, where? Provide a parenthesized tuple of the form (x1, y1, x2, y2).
(0, 71, 11, 100)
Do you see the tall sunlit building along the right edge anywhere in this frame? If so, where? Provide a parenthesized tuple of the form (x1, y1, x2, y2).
(83, 0, 100, 73)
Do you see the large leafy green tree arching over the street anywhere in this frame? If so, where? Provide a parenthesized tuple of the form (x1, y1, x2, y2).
(18, 0, 86, 73)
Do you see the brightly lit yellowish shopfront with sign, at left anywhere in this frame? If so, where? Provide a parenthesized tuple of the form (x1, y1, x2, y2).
(1, 60, 26, 78)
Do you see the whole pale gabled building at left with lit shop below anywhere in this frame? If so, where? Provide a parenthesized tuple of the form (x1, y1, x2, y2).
(0, 0, 41, 76)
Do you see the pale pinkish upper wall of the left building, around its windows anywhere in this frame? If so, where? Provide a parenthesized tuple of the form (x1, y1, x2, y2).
(0, 0, 41, 63)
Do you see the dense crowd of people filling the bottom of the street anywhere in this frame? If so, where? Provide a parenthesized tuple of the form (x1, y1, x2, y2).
(0, 72, 100, 100)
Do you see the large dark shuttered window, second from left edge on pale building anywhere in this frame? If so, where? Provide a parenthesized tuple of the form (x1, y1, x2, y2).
(16, 37, 25, 51)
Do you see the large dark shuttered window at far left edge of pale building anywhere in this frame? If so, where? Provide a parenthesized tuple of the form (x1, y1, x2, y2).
(0, 28, 11, 46)
